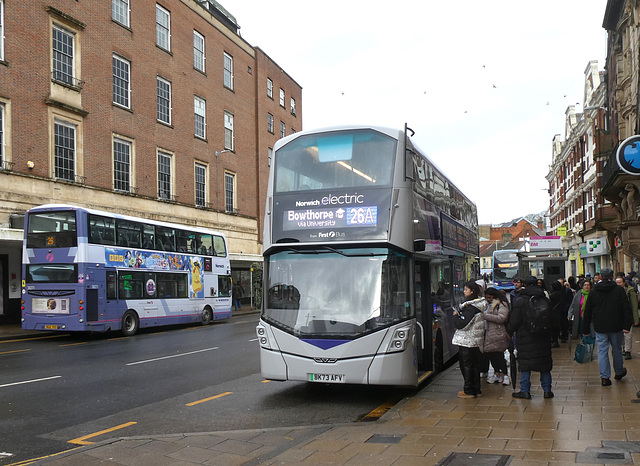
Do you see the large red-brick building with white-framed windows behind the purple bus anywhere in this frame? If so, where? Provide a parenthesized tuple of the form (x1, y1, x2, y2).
(0, 0, 302, 322)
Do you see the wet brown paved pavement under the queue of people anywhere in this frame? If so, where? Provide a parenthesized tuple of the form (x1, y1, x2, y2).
(0, 326, 640, 466)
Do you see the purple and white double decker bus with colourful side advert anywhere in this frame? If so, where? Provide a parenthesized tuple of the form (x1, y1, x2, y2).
(22, 204, 231, 336)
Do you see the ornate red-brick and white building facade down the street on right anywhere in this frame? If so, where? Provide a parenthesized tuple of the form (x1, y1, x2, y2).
(547, 61, 613, 276)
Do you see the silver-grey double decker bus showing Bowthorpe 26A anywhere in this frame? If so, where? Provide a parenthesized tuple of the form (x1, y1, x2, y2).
(256, 126, 479, 386)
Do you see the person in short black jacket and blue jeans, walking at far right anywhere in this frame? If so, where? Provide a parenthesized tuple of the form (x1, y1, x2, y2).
(582, 268, 633, 387)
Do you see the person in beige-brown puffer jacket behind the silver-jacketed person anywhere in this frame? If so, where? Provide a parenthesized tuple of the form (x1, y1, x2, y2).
(484, 288, 510, 385)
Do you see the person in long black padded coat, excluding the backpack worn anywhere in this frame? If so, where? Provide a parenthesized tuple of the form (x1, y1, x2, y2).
(507, 277, 553, 400)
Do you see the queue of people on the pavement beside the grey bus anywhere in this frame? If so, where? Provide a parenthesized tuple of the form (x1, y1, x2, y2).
(452, 268, 640, 400)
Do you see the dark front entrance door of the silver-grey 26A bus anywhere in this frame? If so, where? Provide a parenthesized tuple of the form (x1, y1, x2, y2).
(414, 261, 433, 372)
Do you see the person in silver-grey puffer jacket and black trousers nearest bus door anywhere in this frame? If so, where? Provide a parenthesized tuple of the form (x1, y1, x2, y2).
(452, 281, 487, 398)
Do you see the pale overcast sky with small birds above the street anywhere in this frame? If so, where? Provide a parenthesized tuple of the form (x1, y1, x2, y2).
(228, 0, 606, 224)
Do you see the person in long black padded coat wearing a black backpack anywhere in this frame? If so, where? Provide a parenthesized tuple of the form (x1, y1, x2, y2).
(507, 276, 553, 400)
